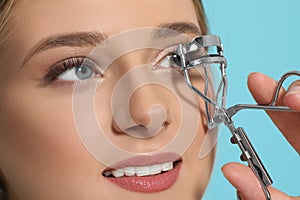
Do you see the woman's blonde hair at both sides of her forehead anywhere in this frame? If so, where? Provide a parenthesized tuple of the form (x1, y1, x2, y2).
(0, 0, 208, 50)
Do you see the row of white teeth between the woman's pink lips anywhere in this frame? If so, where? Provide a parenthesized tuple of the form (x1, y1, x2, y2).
(103, 162, 173, 178)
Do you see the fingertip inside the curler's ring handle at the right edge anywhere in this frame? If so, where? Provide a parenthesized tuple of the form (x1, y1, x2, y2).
(284, 81, 300, 111)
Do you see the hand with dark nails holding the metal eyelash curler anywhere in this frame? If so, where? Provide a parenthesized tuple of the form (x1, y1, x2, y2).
(222, 73, 300, 200)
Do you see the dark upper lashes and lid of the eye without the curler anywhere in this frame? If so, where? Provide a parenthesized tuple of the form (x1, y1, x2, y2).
(43, 56, 102, 85)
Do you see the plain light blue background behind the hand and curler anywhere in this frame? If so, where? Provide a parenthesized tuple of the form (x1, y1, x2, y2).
(203, 0, 300, 200)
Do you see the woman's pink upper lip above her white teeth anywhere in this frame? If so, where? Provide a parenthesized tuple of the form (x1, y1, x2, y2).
(104, 152, 181, 171)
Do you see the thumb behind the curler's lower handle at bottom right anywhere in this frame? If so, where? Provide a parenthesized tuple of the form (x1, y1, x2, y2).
(222, 163, 300, 200)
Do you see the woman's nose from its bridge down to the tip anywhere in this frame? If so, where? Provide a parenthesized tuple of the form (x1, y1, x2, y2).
(110, 52, 169, 132)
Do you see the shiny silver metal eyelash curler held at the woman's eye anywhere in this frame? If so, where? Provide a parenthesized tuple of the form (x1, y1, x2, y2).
(173, 35, 300, 200)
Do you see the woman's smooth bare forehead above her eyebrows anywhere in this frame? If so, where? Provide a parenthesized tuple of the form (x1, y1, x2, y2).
(15, 0, 197, 37)
